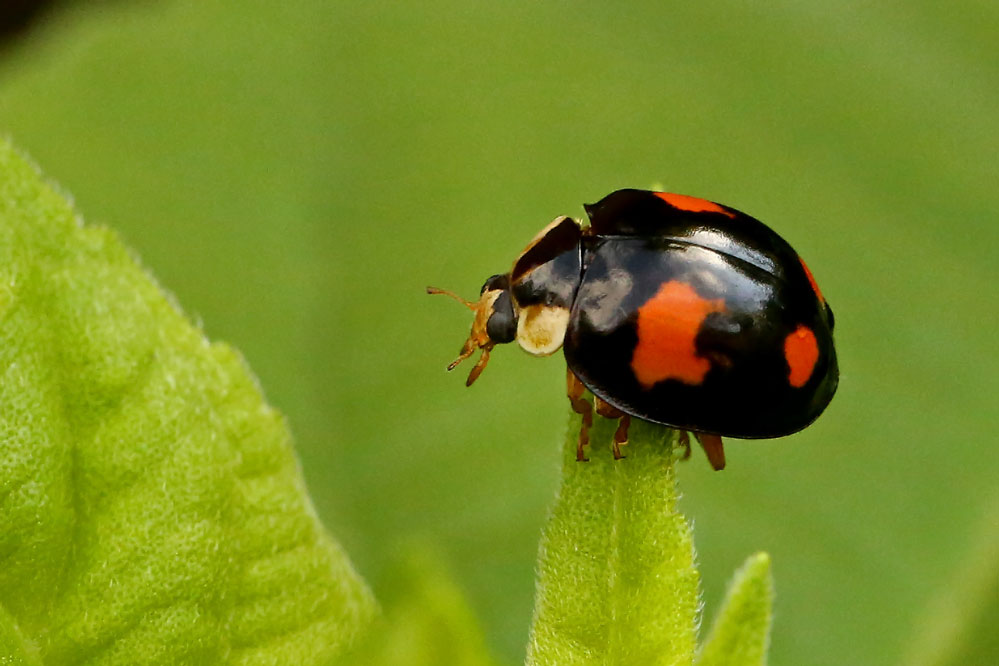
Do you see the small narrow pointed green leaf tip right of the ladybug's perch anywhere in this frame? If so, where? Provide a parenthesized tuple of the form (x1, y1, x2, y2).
(696, 553, 774, 666)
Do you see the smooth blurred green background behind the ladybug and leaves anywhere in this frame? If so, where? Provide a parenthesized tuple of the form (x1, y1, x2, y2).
(0, 0, 999, 665)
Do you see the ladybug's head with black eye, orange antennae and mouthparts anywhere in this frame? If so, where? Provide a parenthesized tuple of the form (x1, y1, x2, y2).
(427, 274, 517, 386)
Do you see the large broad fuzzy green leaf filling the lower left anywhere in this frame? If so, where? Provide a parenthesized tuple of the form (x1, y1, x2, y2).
(0, 141, 374, 664)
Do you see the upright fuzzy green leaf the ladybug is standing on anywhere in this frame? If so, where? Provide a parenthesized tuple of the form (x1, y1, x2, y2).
(527, 417, 699, 666)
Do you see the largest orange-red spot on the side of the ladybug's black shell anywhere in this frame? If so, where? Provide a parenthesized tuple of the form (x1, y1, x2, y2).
(631, 280, 725, 388)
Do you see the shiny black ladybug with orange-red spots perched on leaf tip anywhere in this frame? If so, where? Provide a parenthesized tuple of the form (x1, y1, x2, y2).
(427, 189, 839, 470)
